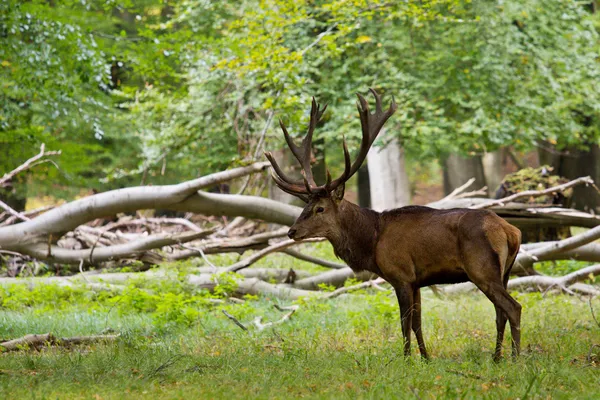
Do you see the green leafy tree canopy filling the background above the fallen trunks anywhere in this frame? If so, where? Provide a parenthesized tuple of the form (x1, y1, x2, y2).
(0, 0, 600, 197)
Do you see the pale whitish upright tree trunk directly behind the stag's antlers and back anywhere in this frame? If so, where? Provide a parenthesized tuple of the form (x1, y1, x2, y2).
(367, 132, 410, 211)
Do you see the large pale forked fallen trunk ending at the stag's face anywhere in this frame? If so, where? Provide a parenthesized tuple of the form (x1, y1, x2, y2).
(0, 162, 300, 249)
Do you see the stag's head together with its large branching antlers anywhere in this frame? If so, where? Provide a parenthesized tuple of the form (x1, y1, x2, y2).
(265, 89, 397, 240)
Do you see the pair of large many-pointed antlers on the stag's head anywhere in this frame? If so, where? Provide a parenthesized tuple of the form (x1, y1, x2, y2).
(265, 89, 398, 201)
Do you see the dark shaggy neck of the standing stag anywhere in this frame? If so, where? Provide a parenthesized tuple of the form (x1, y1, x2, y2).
(327, 200, 379, 273)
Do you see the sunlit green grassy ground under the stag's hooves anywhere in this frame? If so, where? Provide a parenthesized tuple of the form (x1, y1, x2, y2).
(0, 247, 600, 399)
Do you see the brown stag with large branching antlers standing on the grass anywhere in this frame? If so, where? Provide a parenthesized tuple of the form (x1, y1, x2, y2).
(265, 89, 521, 361)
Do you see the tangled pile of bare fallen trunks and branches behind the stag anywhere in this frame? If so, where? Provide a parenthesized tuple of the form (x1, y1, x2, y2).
(0, 147, 600, 299)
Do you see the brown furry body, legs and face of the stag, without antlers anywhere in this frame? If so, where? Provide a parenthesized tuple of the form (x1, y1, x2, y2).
(290, 199, 521, 359)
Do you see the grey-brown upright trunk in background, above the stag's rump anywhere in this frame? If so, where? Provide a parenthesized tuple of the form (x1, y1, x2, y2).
(444, 154, 486, 195)
